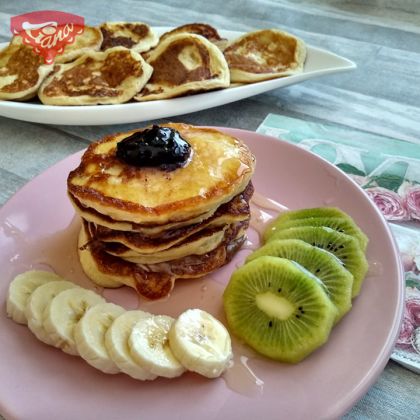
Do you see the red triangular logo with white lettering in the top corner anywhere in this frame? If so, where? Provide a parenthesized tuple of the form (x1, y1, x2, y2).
(10, 10, 85, 64)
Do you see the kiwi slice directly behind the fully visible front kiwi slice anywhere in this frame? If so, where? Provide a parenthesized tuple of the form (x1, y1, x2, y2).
(245, 239, 353, 323)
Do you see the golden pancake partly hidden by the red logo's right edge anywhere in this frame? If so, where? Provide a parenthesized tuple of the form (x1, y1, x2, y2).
(54, 26, 102, 63)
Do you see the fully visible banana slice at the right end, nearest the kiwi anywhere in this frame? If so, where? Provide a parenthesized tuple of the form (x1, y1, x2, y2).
(169, 309, 232, 378)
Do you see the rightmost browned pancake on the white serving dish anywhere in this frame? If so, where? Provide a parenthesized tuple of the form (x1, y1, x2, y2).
(223, 29, 306, 83)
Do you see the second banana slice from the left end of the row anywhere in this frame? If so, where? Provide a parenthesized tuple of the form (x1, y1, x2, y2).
(25, 280, 77, 346)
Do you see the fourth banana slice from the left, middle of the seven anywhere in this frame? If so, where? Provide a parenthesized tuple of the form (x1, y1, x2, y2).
(74, 303, 125, 373)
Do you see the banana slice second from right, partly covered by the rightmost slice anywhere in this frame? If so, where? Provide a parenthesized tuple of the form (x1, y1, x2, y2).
(128, 315, 185, 378)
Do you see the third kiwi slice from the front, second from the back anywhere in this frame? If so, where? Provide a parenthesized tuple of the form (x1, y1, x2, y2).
(268, 226, 368, 297)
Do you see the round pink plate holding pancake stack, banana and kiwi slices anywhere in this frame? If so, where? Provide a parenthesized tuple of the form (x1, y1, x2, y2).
(0, 128, 403, 420)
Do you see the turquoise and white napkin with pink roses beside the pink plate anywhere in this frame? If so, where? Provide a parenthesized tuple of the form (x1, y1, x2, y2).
(257, 114, 420, 373)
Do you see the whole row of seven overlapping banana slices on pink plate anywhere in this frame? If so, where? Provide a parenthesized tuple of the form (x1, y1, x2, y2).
(7, 271, 232, 381)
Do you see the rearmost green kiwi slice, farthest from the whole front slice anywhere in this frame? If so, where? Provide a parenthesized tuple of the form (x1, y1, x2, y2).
(264, 207, 368, 251)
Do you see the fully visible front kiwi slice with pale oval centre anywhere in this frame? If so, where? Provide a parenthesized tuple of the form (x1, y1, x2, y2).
(223, 256, 337, 363)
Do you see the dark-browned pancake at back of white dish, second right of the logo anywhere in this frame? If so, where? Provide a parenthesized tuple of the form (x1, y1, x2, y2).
(99, 22, 159, 53)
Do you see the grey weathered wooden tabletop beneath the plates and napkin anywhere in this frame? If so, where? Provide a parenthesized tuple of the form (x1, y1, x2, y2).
(0, 0, 420, 419)
